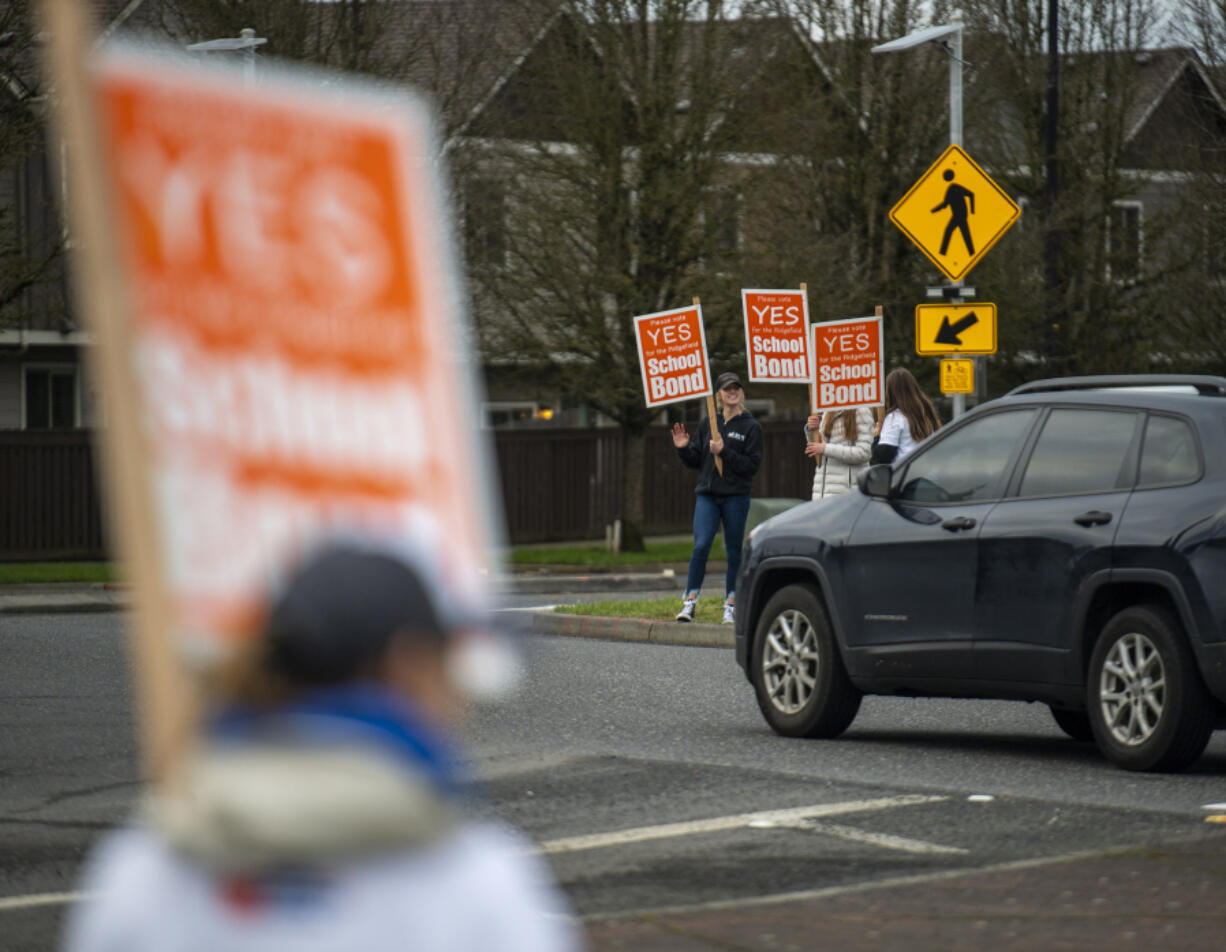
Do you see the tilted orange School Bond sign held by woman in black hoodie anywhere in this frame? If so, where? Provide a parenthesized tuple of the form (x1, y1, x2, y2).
(634, 304, 711, 407)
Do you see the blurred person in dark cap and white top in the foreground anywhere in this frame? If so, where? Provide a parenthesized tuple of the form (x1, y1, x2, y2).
(65, 543, 580, 952)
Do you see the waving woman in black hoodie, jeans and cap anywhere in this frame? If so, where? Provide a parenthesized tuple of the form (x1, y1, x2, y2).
(673, 370, 763, 624)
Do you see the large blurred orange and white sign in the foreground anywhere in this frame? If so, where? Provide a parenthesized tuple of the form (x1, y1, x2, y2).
(96, 50, 495, 638)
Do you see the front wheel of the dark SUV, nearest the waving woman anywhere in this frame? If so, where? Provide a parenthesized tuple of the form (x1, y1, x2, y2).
(750, 584, 863, 738)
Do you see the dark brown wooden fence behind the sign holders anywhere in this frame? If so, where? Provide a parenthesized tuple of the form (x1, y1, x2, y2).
(0, 421, 813, 561)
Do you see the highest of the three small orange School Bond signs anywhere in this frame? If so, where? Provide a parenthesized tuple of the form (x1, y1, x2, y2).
(741, 288, 809, 383)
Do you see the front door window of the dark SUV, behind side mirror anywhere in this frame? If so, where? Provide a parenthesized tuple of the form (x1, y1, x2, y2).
(897, 408, 1035, 502)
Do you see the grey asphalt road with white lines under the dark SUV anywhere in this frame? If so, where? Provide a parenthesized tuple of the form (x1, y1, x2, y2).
(0, 605, 1226, 952)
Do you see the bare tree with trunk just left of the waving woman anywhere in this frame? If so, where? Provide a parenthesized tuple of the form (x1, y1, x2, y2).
(462, 0, 779, 548)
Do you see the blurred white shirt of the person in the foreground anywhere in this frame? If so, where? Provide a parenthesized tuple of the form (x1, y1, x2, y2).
(64, 823, 582, 952)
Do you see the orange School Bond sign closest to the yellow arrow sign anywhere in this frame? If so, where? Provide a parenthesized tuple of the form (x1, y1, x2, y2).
(812, 316, 885, 413)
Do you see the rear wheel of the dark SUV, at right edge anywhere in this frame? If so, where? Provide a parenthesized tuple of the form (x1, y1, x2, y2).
(1086, 605, 1216, 771)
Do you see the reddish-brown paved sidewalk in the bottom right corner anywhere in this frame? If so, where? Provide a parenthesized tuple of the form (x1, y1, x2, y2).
(587, 833, 1226, 952)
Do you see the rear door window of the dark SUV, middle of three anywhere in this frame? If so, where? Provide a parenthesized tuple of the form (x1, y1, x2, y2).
(1021, 408, 1137, 496)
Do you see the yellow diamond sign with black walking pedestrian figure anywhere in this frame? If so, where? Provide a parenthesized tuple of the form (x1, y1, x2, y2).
(890, 140, 1021, 281)
